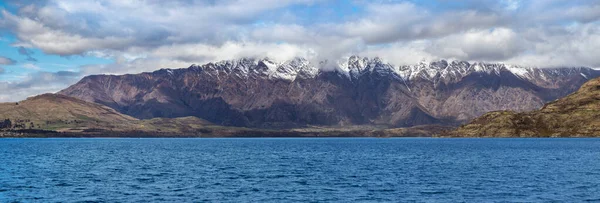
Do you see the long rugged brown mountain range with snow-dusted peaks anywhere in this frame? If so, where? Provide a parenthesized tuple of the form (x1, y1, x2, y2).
(60, 56, 599, 128)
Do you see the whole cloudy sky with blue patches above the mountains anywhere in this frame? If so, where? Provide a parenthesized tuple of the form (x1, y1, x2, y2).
(0, 0, 600, 102)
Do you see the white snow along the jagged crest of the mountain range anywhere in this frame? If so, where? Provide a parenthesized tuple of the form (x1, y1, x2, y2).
(177, 56, 589, 82)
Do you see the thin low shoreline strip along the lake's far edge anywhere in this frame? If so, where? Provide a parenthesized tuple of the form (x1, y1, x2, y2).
(8, 128, 600, 138)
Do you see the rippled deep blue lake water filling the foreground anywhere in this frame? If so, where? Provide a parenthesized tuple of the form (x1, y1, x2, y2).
(0, 138, 600, 202)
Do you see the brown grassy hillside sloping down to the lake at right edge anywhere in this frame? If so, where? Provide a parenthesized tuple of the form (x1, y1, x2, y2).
(442, 79, 600, 137)
